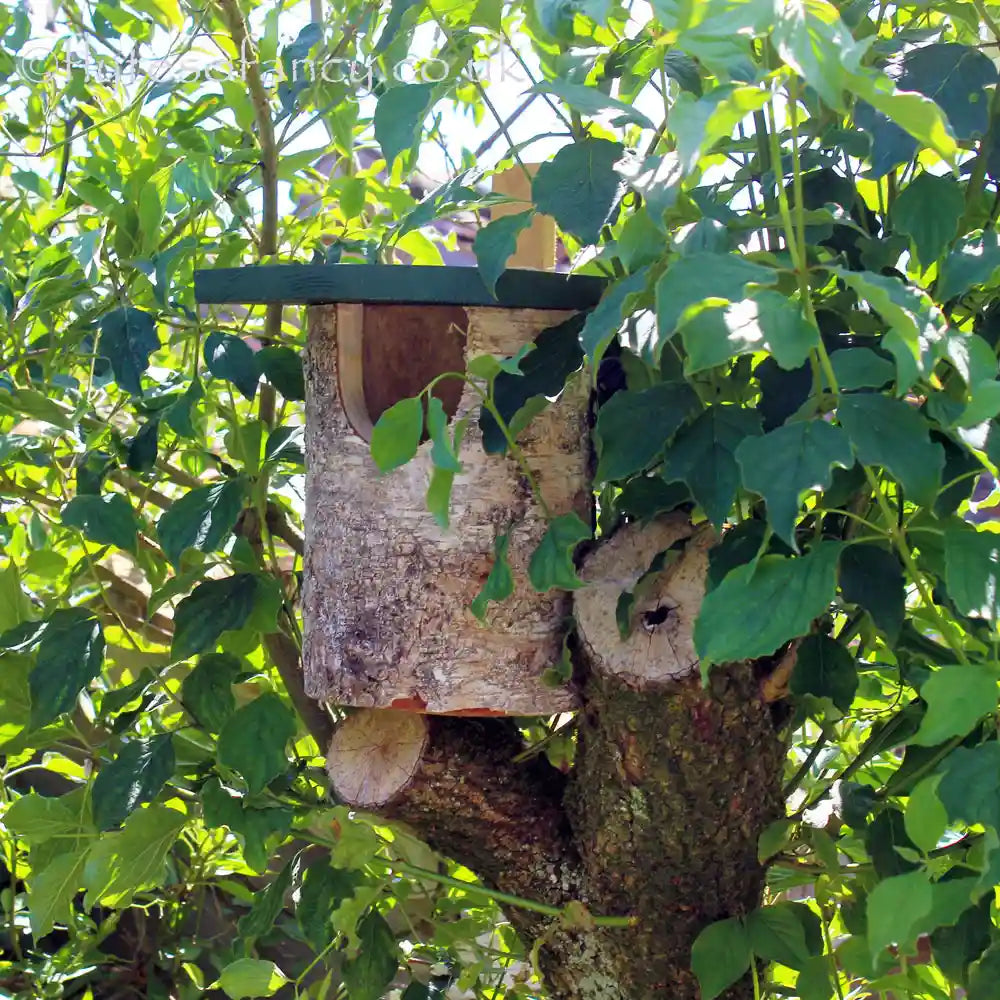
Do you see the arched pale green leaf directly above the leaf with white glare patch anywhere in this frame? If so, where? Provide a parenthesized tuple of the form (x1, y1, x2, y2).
(656, 252, 778, 347)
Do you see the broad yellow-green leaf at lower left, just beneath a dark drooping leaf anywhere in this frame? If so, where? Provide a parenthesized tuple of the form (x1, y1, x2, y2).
(84, 805, 187, 908)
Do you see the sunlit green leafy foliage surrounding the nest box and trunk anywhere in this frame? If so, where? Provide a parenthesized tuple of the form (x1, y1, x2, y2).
(0, 0, 1000, 1000)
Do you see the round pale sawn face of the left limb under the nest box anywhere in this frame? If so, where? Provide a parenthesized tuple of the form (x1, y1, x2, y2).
(326, 710, 427, 809)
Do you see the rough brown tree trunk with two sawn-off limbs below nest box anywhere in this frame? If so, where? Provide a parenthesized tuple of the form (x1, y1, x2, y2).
(328, 517, 783, 1000)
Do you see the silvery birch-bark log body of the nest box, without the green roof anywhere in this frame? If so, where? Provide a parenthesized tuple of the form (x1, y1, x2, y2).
(303, 306, 589, 715)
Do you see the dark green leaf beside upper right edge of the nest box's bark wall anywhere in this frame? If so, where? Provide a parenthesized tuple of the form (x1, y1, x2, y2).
(594, 382, 698, 482)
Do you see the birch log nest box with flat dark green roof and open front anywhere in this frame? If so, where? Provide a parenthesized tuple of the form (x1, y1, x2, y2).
(195, 264, 603, 715)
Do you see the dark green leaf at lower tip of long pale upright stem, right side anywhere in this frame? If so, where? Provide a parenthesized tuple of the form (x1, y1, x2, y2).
(837, 395, 944, 504)
